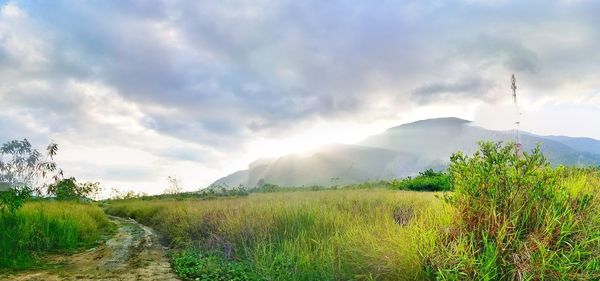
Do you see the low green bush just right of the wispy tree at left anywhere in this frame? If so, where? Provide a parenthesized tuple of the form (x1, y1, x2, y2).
(47, 178, 101, 200)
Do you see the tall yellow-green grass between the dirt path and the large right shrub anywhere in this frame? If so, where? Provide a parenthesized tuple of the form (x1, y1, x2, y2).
(108, 190, 452, 280)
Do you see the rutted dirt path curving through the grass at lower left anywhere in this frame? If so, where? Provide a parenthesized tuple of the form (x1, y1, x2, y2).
(0, 217, 178, 281)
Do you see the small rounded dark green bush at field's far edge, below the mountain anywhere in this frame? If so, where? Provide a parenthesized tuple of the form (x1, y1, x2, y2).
(389, 169, 452, 191)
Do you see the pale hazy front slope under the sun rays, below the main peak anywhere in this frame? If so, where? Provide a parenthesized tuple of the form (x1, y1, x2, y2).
(214, 144, 418, 186)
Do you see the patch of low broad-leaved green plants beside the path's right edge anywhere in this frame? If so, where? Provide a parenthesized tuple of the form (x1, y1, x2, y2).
(172, 250, 265, 281)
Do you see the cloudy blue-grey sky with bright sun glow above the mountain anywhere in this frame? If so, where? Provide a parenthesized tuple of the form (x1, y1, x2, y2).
(0, 0, 600, 193)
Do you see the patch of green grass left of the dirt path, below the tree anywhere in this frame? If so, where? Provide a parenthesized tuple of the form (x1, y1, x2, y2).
(0, 201, 111, 270)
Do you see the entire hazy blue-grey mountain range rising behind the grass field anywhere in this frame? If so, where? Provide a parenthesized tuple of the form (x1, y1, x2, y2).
(213, 117, 600, 187)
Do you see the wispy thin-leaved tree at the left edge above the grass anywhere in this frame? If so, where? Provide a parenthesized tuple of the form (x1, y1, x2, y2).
(0, 139, 62, 213)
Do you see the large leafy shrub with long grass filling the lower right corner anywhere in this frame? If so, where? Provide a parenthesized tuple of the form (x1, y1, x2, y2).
(422, 142, 600, 280)
